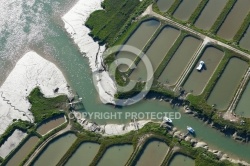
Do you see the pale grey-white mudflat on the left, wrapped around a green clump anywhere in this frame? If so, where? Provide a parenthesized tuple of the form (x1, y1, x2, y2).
(0, 52, 70, 134)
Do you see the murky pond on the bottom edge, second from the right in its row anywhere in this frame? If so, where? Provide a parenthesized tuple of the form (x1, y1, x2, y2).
(136, 140, 169, 166)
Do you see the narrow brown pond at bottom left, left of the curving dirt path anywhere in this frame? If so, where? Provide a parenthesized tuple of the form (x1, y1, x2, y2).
(6, 136, 39, 166)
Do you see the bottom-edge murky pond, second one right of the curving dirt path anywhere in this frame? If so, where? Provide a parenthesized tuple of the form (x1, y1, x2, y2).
(65, 142, 100, 166)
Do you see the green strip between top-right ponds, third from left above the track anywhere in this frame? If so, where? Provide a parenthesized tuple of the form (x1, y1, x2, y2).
(210, 0, 237, 34)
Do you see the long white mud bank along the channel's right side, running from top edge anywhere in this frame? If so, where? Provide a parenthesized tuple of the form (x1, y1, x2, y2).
(62, 0, 116, 103)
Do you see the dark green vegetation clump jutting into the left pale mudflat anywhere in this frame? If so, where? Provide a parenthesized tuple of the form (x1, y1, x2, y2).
(28, 88, 68, 123)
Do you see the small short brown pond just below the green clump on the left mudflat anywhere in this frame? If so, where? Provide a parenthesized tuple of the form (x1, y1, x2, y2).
(37, 117, 65, 135)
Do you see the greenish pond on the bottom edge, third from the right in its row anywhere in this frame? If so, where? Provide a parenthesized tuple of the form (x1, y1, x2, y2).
(97, 145, 133, 166)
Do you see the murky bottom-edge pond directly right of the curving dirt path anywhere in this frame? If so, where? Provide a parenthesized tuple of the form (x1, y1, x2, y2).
(33, 133, 76, 166)
